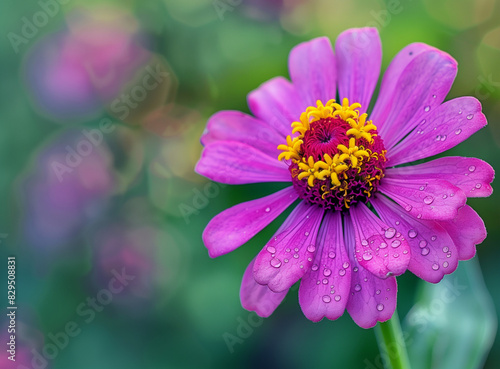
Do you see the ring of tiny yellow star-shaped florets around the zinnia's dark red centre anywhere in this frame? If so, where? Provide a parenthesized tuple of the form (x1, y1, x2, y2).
(278, 98, 378, 187)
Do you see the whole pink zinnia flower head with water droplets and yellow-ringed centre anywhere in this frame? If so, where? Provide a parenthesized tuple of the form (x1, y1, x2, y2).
(196, 28, 494, 328)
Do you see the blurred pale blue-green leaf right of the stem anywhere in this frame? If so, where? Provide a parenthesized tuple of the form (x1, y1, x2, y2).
(403, 258, 497, 369)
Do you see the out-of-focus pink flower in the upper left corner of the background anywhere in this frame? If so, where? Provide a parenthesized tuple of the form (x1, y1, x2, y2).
(24, 7, 150, 123)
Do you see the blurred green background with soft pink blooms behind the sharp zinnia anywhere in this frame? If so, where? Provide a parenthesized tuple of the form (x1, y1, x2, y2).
(0, 0, 500, 369)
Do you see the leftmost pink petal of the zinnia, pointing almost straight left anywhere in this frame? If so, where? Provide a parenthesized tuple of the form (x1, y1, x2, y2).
(195, 141, 291, 184)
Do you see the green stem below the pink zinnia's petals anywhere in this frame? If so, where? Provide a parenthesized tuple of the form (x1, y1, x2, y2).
(375, 311, 411, 369)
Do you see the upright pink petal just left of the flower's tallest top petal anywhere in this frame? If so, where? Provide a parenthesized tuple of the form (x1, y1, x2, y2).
(288, 37, 336, 110)
